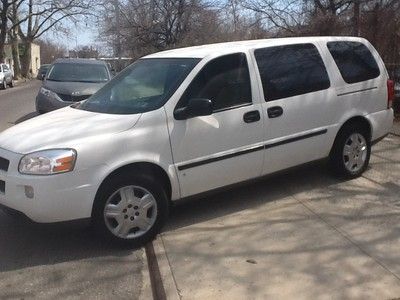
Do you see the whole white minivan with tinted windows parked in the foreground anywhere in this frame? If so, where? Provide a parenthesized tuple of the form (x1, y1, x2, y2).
(0, 37, 394, 245)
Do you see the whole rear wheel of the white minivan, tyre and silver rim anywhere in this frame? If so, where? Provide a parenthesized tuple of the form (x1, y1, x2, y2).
(330, 124, 371, 178)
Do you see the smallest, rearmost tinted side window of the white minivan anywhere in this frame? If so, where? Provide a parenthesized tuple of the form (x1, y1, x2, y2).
(328, 42, 380, 83)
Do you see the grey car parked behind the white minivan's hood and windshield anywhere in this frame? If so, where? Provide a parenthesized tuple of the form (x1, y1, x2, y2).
(36, 58, 111, 114)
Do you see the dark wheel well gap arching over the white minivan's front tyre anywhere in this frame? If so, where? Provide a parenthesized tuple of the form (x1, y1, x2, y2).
(98, 162, 172, 200)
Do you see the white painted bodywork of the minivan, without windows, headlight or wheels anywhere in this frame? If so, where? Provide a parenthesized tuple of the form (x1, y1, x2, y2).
(0, 37, 393, 244)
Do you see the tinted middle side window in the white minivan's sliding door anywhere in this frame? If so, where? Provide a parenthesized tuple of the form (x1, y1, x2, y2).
(254, 44, 330, 101)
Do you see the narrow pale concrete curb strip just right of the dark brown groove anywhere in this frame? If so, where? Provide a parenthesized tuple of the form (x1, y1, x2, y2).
(153, 235, 181, 300)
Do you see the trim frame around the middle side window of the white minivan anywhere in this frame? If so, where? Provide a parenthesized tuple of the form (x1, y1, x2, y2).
(253, 42, 332, 103)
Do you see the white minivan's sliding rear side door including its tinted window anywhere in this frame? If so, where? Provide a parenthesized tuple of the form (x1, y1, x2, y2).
(254, 43, 334, 174)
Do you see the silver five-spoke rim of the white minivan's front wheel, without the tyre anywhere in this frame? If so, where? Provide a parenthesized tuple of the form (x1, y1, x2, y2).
(104, 185, 157, 239)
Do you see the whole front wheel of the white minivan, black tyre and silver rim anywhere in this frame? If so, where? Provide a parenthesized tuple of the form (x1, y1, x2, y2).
(92, 174, 168, 247)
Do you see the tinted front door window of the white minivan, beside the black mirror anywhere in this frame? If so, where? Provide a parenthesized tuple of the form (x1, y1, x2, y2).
(178, 53, 252, 111)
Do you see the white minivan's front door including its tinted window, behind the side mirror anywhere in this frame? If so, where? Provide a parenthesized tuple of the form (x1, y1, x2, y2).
(168, 53, 263, 197)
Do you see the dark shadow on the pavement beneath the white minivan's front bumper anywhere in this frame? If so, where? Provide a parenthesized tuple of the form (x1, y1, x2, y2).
(0, 210, 132, 272)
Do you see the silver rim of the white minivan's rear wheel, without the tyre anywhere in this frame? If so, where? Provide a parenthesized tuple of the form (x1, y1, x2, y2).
(343, 133, 368, 173)
